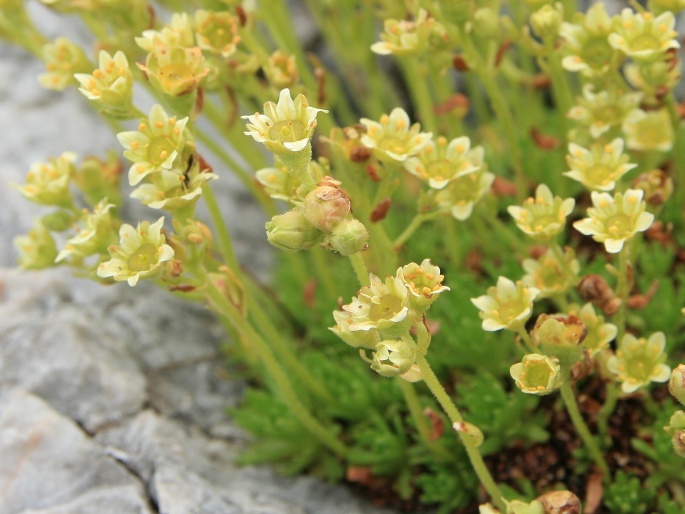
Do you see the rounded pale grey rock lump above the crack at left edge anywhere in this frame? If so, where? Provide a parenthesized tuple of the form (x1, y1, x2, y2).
(0, 273, 146, 432)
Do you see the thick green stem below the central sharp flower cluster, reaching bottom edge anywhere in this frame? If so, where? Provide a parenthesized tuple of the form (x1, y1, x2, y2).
(416, 355, 507, 512)
